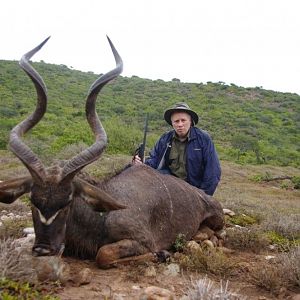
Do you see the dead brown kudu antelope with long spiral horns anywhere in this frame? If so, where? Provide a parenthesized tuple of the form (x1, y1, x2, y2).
(0, 39, 224, 267)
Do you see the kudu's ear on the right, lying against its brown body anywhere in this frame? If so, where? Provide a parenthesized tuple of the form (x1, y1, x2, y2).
(72, 178, 127, 212)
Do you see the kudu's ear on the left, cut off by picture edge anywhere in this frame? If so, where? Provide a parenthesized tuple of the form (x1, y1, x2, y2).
(0, 176, 32, 204)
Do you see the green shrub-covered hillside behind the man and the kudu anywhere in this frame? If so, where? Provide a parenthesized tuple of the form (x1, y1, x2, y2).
(0, 60, 300, 167)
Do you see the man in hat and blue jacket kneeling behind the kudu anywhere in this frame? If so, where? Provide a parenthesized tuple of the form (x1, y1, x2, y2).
(133, 102, 221, 196)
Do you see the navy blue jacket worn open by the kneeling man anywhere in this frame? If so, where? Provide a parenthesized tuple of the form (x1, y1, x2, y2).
(145, 127, 221, 196)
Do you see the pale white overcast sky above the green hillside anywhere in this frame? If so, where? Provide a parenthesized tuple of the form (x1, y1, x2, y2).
(0, 0, 300, 94)
